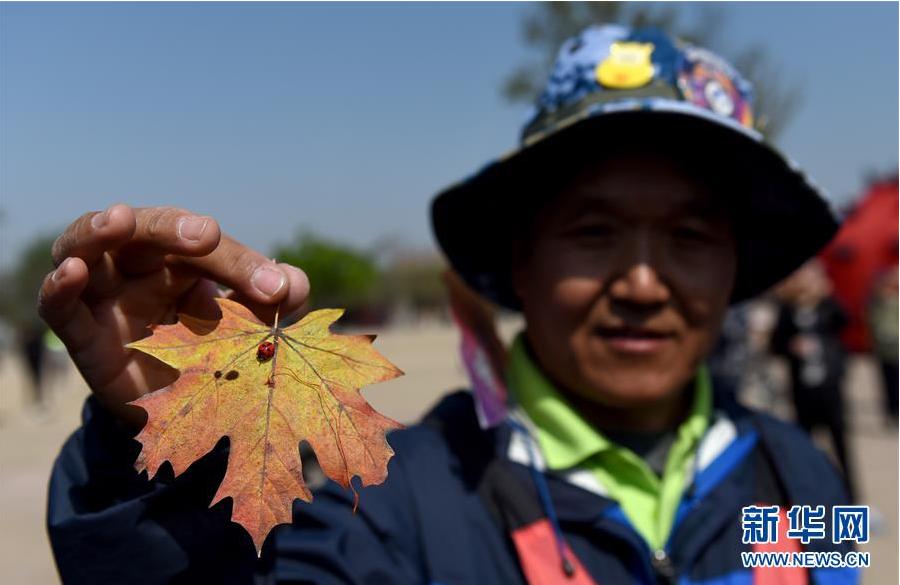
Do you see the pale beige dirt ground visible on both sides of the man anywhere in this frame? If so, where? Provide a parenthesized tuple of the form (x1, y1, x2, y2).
(0, 323, 898, 585)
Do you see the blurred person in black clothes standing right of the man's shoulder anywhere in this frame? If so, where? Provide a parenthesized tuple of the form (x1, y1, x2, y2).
(771, 260, 855, 498)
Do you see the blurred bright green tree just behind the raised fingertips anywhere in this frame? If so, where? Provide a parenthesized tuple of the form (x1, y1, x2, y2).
(274, 232, 379, 309)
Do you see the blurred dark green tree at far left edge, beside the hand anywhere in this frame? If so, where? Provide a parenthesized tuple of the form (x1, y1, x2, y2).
(0, 235, 54, 329)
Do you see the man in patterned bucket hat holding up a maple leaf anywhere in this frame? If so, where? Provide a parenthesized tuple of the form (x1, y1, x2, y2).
(40, 26, 858, 585)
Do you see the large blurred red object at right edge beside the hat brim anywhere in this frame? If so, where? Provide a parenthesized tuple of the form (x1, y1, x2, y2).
(820, 176, 898, 351)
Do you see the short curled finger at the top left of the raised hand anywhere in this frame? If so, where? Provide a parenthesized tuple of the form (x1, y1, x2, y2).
(52, 205, 135, 266)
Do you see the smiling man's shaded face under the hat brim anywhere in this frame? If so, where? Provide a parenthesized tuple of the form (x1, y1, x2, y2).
(513, 155, 737, 408)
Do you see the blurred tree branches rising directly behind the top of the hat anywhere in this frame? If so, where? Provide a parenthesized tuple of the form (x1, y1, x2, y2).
(502, 2, 801, 140)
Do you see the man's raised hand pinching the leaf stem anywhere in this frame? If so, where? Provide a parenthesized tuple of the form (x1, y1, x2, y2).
(38, 205, 309, 427)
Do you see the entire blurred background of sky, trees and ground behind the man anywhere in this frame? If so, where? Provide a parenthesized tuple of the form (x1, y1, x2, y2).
(0, 2, 898, 584)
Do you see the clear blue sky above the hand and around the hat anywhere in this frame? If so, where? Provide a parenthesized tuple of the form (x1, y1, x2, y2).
(0, 2, 898, 270)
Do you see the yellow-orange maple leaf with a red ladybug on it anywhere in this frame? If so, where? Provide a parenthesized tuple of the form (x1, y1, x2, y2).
(127, 299, 403, 554)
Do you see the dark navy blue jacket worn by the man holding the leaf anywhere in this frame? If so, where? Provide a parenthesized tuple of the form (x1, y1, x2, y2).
(48, 392, 857, 585)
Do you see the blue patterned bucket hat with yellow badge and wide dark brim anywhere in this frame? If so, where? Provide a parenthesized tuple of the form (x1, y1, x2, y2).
(431, 25, 838, 310)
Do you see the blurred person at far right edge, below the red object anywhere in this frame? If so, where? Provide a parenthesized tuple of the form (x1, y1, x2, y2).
(866, 266, 900, 426)
